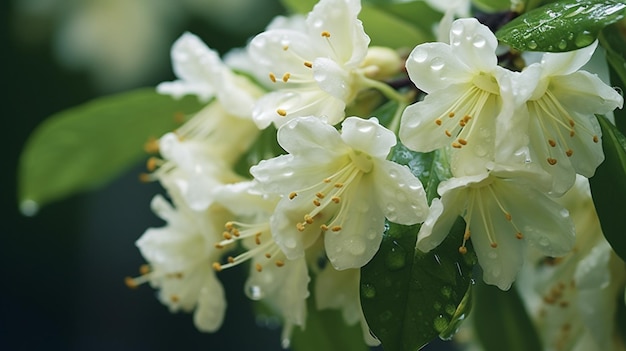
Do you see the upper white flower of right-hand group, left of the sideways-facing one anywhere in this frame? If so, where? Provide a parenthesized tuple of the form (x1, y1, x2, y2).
(399, 18, 522, 176)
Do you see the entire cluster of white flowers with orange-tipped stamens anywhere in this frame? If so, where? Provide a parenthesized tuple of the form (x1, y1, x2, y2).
(128, 0, 623, 347)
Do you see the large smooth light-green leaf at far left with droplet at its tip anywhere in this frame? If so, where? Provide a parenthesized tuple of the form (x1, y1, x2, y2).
(18, 88, 201, 215)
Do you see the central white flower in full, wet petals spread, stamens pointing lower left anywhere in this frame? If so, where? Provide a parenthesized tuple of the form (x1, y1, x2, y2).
(250, 117, 428, 269)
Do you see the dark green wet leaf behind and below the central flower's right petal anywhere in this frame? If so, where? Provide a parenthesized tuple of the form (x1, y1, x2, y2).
(361, 144, 476, 351)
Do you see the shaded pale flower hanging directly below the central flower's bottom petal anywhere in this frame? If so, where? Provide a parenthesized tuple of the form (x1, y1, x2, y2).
(315, 265, 380, 346)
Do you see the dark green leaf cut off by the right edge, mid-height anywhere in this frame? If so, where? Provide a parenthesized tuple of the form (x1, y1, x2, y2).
(589, 116, 626, 261)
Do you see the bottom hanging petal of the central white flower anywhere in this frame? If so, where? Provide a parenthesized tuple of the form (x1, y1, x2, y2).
(324, 178, 385, 270)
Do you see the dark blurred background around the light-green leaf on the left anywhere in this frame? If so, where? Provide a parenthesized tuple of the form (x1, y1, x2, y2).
(0, 0, 283, 350)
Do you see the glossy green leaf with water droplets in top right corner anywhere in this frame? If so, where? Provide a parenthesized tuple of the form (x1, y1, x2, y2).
(496, 0, 626, 52)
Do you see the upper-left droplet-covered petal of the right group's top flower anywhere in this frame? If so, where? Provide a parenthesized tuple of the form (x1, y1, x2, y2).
(406, 43, 474, 93)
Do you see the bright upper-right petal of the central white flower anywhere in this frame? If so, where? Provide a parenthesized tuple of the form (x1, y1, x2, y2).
(341, 117, 396, 159)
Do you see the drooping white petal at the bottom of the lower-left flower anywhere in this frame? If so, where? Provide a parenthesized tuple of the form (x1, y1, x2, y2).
(193, 272, 226, 332)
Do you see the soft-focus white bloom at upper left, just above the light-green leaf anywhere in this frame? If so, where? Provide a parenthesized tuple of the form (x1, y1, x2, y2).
(157, 33, 261, 119)
